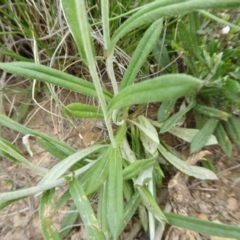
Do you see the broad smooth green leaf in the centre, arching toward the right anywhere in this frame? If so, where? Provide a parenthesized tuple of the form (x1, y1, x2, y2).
(108, 74, 201, 112)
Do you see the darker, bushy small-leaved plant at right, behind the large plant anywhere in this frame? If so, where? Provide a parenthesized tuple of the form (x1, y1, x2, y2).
(172, 10, 240, 156)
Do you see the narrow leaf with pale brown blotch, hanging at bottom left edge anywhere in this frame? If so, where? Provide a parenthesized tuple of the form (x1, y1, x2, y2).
(39, 189, 61, 240)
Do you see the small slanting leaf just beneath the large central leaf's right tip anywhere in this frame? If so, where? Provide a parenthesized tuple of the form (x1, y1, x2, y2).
(160, 101, 195, 133)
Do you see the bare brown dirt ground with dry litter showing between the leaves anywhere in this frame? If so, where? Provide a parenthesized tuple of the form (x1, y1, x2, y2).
(0, 98, 240, 240)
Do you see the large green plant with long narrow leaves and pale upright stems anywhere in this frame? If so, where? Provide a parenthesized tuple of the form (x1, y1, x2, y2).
(0, 0, 240, 239)
